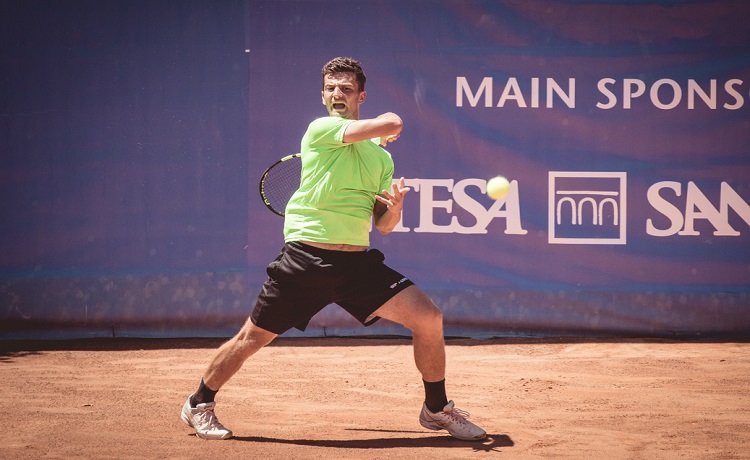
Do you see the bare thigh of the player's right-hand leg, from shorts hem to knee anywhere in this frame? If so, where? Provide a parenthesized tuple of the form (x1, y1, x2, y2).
(374, 285, 443, 331)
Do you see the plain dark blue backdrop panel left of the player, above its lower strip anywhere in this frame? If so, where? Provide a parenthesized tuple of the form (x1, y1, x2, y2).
(0, 1, 248, 276)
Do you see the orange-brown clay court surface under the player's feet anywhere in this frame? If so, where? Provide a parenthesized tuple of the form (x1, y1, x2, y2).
(0, 338, 750, 460)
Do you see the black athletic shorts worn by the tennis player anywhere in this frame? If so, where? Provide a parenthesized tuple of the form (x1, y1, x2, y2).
(251, 242, 414, 334)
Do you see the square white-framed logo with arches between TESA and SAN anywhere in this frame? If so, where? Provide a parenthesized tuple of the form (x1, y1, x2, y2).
(549, 171, 627, 244)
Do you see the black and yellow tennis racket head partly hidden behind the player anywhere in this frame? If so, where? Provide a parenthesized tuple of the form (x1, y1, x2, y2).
(260, 153, 302, 217)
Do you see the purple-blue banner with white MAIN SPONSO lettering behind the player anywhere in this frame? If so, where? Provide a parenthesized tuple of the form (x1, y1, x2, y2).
(247, 1, 750, 332)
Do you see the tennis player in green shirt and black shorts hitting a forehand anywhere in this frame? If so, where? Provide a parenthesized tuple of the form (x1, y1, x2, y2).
(181, 58, 485, 440)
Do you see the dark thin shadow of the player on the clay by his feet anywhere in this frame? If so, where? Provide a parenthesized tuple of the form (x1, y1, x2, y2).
(233, 430, 513, 452)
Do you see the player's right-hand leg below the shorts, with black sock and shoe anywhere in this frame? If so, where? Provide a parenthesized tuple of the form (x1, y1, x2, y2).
(374, 285, 486, 441)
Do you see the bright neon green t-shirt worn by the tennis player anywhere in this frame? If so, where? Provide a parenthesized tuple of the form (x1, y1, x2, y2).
(284, 117, 393, 246)
